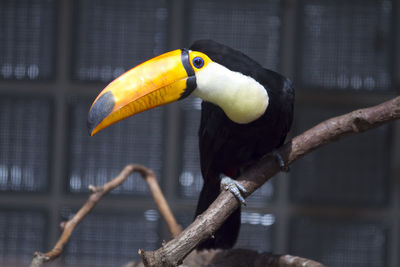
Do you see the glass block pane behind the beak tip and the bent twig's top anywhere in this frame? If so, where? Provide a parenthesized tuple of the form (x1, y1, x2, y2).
(68, 97, 164, 196)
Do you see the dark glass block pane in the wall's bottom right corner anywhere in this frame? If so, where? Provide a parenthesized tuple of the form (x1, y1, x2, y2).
(290, 218, 388, 267)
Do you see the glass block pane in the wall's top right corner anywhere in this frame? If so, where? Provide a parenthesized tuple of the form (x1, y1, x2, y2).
(298, 0, 392, 90)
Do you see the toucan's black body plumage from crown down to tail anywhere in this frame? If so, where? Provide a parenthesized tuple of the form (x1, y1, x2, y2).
(190, 40, 294, 249)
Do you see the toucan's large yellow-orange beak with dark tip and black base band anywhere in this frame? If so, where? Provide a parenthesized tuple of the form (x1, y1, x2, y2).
(88, 49, 196, 136)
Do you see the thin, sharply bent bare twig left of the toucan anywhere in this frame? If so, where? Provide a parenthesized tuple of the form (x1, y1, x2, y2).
(30, 164, 180, 267)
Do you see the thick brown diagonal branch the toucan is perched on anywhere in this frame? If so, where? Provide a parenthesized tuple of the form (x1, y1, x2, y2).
(141, 97, 400, 266)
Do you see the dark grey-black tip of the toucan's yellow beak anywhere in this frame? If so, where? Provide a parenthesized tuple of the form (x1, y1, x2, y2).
(87, 92, 115, 136)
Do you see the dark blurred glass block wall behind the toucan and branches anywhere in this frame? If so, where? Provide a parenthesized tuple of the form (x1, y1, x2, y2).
(0, 0, 400, 267)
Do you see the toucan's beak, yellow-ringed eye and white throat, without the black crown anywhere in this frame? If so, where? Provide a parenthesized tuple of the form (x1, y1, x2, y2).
(88, 39, 268, 135)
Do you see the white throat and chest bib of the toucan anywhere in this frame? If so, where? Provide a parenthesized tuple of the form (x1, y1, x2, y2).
(194, 62, 269, 124)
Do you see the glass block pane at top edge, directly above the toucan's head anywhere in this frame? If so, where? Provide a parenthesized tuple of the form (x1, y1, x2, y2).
(188, 0, 283, 70)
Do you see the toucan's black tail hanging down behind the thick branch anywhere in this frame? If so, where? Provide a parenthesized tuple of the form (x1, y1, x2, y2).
(195, 179, 240, 250)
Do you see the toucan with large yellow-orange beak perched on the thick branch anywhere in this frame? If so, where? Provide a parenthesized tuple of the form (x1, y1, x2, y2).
(88, 40, 294, 250)
